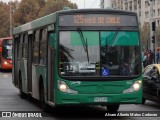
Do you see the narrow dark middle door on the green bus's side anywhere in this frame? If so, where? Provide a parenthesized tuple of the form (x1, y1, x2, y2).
(27, 34, 33, 94)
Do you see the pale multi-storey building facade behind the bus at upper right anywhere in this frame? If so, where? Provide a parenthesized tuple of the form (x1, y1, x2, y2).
(101, 0, 160, 26)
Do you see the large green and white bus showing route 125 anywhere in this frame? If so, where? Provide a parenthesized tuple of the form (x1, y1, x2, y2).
(13, 9, 142, 111)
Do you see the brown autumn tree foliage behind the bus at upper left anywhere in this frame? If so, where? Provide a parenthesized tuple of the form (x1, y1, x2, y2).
(0, 0, 77, 38)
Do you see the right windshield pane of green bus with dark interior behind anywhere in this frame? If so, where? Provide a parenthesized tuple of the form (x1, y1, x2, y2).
(100, 31, 140, 76)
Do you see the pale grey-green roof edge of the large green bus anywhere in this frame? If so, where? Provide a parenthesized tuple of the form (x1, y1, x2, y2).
(13, 9, 137, 35)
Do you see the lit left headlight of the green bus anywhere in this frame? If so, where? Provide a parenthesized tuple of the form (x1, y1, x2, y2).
(58, 80, 78, 94)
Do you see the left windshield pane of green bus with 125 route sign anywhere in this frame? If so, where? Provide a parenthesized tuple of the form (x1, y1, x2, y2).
(59, 31, 100, 76)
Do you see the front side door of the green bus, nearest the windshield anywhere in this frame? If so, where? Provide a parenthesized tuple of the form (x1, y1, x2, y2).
(47, 33, 55, 103)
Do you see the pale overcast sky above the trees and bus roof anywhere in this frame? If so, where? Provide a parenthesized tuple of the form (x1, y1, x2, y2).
(2, 0, 100, 8)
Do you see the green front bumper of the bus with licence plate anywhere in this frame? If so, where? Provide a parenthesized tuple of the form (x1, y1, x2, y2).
(55, 90, 142, 105)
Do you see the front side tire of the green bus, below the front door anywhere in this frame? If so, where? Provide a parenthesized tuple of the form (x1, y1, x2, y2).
(39, 83, 49, 112)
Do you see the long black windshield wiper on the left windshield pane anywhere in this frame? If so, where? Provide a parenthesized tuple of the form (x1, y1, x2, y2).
(77, 28, 89, 63)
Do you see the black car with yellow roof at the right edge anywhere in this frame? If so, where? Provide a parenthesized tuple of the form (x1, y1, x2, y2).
(142, 64, 160, 104)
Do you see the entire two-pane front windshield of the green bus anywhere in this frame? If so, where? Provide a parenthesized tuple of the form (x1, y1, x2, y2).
(59, 30, 141, 77)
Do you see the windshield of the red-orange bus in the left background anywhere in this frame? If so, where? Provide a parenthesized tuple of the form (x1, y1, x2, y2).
(2, 40, 12, 60)
